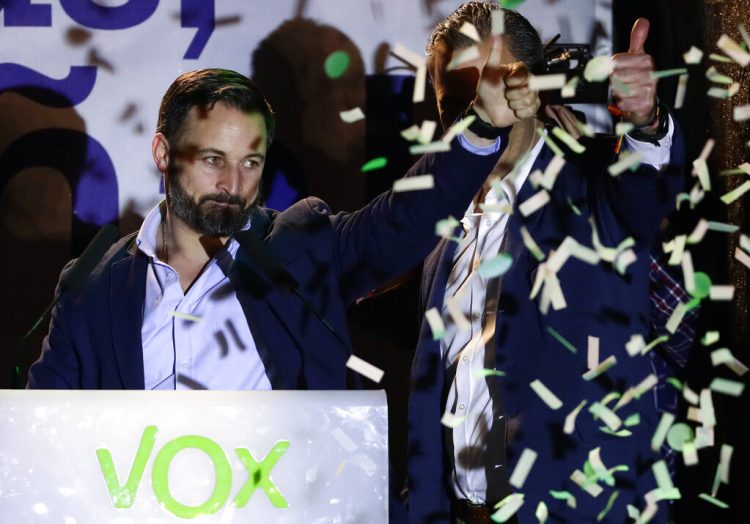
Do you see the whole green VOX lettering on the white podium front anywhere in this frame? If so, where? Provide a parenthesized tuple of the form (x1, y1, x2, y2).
(96, 426, 289, 519)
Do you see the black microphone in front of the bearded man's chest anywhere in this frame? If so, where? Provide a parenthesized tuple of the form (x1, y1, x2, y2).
(234, 230, 351, 356)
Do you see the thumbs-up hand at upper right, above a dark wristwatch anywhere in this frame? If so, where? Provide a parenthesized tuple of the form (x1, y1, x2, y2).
(610, 18, 656, 129)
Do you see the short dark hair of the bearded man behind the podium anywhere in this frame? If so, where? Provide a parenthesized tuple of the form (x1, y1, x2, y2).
(156, 69, 276, 146)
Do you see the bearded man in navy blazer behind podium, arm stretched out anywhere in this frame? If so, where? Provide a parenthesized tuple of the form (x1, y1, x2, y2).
(29, 64, 539, 398)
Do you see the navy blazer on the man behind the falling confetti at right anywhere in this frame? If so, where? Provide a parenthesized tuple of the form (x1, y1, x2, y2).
(408, 130, 685, 523)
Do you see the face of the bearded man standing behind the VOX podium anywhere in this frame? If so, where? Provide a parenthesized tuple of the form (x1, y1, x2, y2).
(166, 103, 267, 237)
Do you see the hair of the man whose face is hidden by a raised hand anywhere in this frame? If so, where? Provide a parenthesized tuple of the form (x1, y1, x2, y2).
(427, 2, 544, 73)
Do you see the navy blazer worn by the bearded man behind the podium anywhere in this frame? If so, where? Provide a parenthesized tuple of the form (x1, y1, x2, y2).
(28, 141, 506, 389)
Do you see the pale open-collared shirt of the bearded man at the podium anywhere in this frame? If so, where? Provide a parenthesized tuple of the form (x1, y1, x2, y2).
(136, 205, 271, 390)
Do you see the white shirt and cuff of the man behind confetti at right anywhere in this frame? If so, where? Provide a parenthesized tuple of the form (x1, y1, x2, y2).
(440, 116, 674, 504)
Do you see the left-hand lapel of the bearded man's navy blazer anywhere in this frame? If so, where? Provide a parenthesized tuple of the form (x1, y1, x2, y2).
(109, 245, 148, 389)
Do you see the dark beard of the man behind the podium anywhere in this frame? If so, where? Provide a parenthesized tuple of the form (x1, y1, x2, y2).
(167, 170, 255, 237)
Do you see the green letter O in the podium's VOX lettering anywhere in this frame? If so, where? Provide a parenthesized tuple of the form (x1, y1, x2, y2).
(151, 435, 232, 519)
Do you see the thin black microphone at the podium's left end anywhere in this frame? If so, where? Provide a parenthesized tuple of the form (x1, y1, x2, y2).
(13, 224, 120, 389)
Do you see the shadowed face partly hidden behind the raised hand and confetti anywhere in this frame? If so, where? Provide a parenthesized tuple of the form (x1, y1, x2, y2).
(429, 39, 517, 129)
